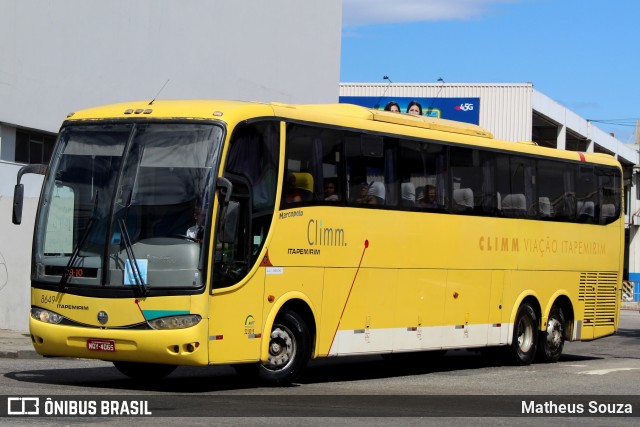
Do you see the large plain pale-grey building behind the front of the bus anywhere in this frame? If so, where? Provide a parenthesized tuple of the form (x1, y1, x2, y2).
(0, 0, 342, 330)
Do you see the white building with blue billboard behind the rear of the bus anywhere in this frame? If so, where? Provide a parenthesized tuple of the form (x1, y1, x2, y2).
(340, 82, 640, 301)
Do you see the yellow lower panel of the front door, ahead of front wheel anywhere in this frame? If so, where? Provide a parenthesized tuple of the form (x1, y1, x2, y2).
(209, 268, 269, 364)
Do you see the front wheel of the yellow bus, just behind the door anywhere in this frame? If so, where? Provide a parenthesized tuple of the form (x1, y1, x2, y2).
(258, 309, 311, 385)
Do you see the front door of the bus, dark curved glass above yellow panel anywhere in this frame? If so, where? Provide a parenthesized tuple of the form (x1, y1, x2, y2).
(209, 121, 279, 363)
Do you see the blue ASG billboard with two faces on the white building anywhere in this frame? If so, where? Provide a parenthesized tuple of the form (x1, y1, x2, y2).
(340, 96, 480, 125)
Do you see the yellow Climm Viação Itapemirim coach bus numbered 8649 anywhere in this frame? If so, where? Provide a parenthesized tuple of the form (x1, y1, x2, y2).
(14, 100, 624, 383)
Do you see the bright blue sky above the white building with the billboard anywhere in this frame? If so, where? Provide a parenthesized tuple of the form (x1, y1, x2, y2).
(340, 0, 640, 143)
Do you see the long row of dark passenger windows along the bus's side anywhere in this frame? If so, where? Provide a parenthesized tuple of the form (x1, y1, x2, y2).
(280, 123, 621, 229)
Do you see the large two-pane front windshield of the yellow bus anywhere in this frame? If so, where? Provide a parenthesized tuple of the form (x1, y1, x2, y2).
(32, 122, 223, 293)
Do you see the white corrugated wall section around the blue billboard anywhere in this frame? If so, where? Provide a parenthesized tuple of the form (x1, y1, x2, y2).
(340, 83, 533, 141)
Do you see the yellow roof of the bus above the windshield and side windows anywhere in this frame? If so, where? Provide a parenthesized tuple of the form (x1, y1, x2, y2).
(67, 100, 619, 167)
